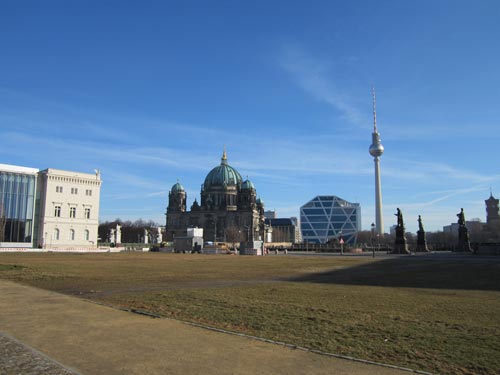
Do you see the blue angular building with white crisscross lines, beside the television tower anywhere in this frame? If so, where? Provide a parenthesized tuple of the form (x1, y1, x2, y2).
(300, 195, 361, 245)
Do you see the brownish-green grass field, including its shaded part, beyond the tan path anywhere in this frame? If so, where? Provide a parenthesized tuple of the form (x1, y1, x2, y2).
(0, 253, 500, 374)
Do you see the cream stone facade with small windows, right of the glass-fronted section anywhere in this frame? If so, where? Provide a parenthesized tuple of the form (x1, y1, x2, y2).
(38, 168, 101, 248)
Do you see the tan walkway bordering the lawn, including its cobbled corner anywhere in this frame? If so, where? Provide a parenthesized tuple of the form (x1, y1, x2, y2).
(0, 281, 410, 375)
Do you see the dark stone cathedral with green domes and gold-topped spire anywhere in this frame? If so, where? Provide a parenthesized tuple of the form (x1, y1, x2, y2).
(165, 150, 264, 242)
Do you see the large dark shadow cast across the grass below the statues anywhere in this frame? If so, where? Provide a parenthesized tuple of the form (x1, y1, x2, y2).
(290, 254, 500, 291)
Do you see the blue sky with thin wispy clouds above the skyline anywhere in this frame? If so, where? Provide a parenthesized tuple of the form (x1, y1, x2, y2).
(0, 0, 500, 231)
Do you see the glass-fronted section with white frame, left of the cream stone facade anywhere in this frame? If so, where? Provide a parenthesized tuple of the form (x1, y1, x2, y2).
(0, 164, 38, 247)
